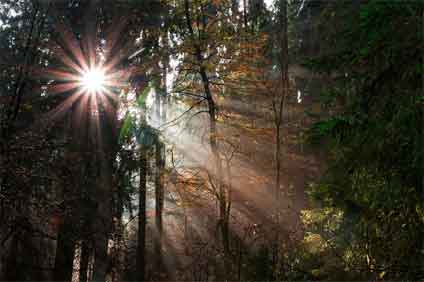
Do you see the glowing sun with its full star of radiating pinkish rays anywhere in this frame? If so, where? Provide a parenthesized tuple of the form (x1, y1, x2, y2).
(32, 14, 140, 152)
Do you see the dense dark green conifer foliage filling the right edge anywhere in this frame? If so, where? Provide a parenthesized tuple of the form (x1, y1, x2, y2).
(302, 1, 424, 279)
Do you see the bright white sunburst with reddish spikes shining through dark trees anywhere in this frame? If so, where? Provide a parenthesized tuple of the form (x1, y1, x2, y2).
(39, 18, 134, 142)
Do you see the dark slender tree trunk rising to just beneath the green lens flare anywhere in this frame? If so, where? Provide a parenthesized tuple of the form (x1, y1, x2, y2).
(136, 148, 147, 281)
